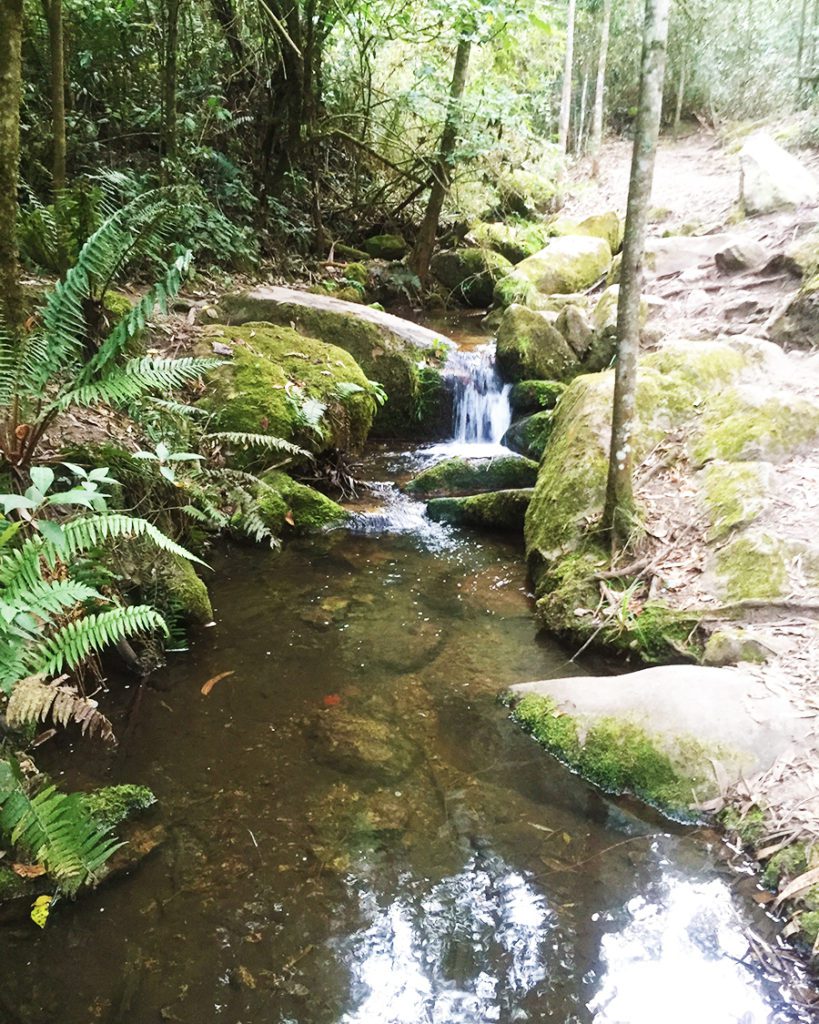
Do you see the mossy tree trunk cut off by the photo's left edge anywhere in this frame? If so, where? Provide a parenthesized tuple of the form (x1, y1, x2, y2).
(0, 0, 23, 332)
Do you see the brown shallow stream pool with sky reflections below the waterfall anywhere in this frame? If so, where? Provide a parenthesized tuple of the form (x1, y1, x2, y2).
(0, 339, 808, 1024)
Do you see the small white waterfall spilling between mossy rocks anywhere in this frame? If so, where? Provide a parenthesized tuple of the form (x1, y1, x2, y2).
(446, 344, 512, 445)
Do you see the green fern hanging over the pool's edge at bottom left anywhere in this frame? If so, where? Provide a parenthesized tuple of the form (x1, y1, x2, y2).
(0, 761, 122, 895)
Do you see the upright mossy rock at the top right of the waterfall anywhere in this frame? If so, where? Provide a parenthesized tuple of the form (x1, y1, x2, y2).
(497, 304, 579, 381)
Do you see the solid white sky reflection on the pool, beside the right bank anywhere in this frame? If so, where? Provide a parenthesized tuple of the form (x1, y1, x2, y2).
(589, 877, 772, 1024)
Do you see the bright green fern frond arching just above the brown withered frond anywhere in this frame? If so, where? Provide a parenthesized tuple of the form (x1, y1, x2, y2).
(29, 604, 168, 676)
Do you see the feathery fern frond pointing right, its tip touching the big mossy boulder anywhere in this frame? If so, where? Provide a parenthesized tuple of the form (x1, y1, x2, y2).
(53, 355, 222, 410)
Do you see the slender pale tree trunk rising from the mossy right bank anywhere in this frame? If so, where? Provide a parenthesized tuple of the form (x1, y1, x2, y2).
(603, 0, 670, 547)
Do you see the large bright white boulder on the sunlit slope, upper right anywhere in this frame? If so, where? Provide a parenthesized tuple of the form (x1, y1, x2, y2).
(739, 132, 819, 216)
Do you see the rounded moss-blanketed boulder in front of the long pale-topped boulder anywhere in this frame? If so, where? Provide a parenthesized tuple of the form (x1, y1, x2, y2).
(204, 323, 376, 454)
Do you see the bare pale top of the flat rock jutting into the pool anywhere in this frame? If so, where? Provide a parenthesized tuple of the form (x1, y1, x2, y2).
(511, 665, 811, 782)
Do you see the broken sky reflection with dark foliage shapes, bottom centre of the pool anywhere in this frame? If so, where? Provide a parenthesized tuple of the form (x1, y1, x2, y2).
(342, 857, 555, 1024)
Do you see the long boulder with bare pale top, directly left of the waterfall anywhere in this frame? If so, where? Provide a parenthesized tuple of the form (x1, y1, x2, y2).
(218, 288, 451, 437)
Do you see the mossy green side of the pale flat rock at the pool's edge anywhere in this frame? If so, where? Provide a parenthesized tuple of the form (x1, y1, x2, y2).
(513, 694, 713, 819)
